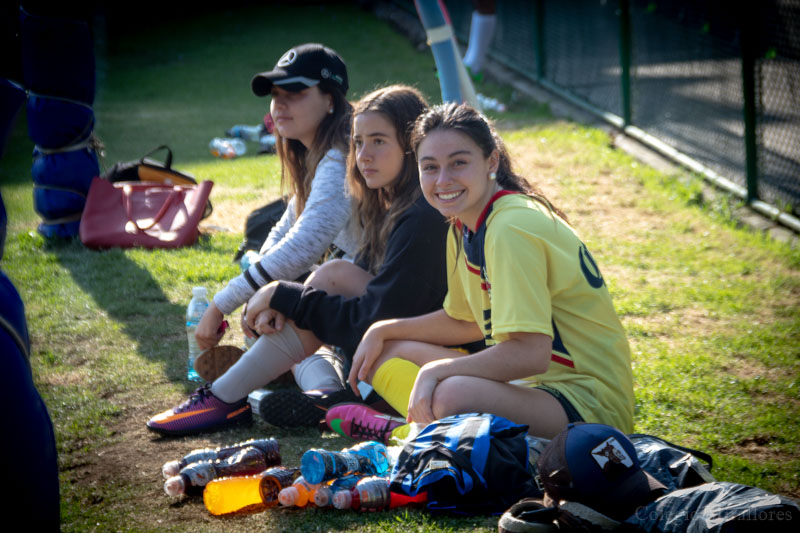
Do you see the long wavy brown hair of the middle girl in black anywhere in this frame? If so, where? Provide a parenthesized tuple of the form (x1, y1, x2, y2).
(347, 85, 428, 273)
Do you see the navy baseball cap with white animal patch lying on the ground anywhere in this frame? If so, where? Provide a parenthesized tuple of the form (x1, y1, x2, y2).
(537, 422, 667, 520)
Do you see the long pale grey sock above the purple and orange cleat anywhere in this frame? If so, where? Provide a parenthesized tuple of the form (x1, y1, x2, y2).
(211, 324, 305, 403)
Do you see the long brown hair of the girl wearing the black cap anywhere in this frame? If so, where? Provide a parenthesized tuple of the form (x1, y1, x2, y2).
(275, 86, 353, 216)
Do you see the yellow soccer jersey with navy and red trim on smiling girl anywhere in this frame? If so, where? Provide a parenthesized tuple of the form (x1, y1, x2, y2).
(444, 191, 634, 433)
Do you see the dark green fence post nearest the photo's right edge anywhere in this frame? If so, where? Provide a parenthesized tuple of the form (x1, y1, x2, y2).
(739, 2, 758, 203)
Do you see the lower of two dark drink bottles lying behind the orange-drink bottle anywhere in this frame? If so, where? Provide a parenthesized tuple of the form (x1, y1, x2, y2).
(164, 446, 282, 496)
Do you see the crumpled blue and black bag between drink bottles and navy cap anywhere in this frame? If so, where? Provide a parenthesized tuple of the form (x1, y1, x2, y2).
(390, 413, 542, 515)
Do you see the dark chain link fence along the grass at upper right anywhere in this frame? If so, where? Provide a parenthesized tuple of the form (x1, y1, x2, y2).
(394, 0, 800, 215)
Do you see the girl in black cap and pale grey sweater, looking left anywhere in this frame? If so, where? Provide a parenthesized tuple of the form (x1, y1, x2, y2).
(147, 43, 358, 434)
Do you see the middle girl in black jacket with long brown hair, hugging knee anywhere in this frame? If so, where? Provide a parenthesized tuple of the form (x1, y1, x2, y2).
(147, 85, 447, 434)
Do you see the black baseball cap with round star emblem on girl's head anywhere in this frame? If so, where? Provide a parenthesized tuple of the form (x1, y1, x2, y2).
(251, 43, 349, 96)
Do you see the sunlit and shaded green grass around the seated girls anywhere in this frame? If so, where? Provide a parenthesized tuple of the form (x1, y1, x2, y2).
(0, 5, 800, 532)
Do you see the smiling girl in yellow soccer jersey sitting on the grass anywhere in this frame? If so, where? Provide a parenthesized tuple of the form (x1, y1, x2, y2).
(350, 104, 634, 438)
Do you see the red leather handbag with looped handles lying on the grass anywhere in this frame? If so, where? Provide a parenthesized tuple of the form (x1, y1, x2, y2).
(79, 178, 214, 248)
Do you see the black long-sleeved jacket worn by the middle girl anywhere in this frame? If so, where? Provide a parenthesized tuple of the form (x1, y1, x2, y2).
(270, 192, 447, 356)
